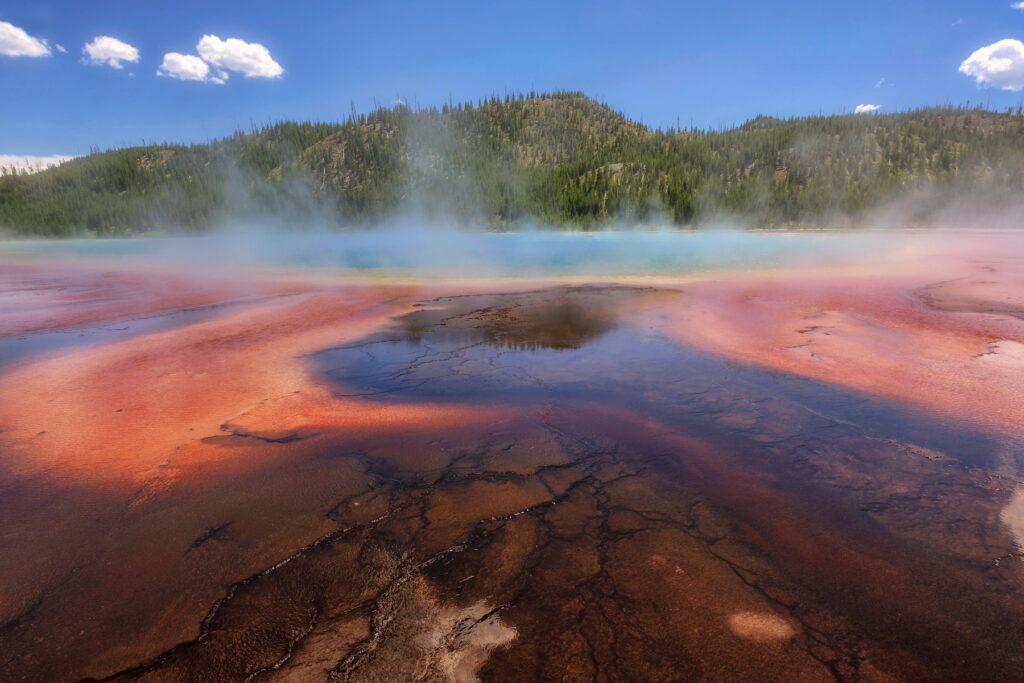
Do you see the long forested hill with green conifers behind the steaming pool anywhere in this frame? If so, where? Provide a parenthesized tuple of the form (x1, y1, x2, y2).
(6, 93, 1024, 236)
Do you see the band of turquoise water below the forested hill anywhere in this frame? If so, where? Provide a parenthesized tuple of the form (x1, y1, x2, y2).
(0, 228, 892, 276)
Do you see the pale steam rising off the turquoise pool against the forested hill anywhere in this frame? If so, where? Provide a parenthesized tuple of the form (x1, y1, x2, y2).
(0, 97, 1024, 279)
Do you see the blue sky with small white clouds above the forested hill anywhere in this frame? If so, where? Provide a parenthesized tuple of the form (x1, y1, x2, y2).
(0, 0, 1024, 164)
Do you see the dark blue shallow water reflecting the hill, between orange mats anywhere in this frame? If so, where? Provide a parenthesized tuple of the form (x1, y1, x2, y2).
(313, 287, 1003, 466)
